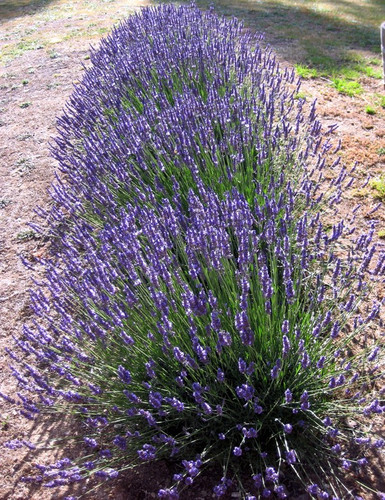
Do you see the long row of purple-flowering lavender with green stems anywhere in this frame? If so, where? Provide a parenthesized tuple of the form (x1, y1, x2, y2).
(3, 6, 385, 500)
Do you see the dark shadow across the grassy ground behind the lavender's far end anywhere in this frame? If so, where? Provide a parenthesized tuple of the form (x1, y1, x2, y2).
(158, 0, 385, 75)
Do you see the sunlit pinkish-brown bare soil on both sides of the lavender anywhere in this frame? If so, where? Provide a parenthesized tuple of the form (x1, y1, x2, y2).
(0, 0, 385, 500)
